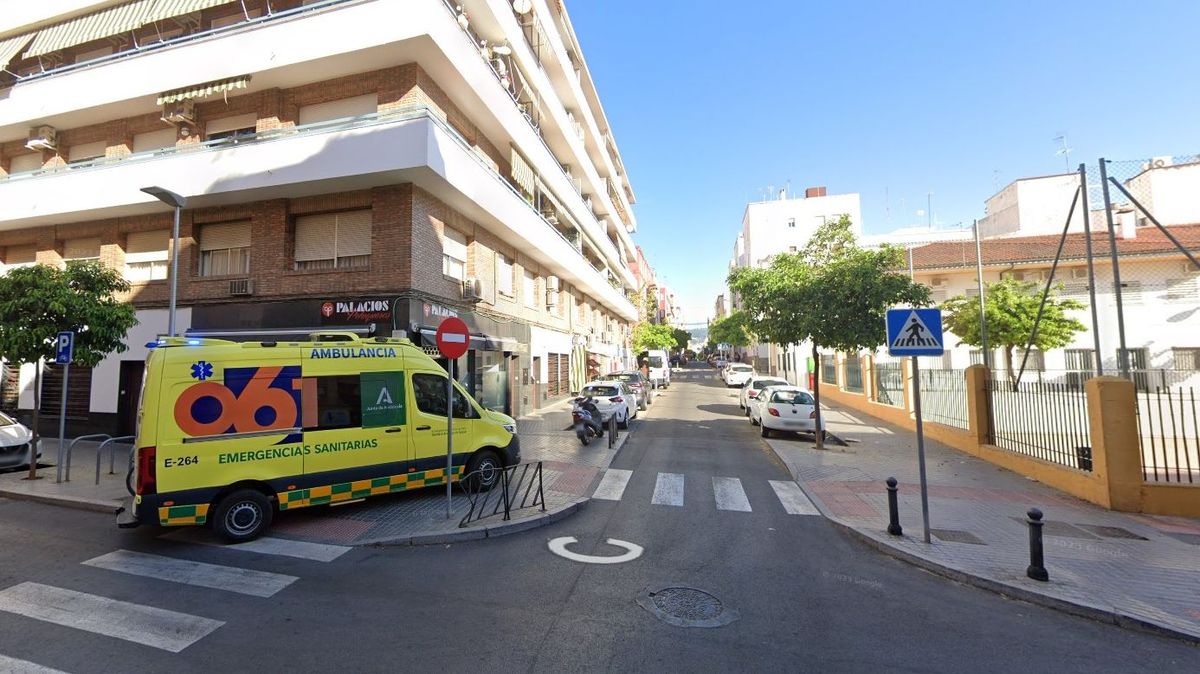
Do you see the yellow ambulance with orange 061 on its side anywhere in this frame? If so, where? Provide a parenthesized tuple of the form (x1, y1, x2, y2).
(118, 332, 521, 541)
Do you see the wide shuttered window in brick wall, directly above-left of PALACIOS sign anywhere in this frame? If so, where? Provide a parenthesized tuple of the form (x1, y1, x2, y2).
(295, 209, 371, 271)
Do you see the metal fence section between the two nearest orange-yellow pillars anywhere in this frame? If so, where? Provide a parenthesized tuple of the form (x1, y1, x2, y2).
(988, 380, 1092, 471)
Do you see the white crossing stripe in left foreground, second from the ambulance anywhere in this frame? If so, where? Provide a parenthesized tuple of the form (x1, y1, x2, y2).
(83, 550, 299, 597)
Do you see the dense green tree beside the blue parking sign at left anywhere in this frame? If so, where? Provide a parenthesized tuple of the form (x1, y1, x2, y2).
(0, 261, 137, 479)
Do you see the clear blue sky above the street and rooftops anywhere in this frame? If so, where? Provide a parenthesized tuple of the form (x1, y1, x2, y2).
(568, 0, 1200, 321)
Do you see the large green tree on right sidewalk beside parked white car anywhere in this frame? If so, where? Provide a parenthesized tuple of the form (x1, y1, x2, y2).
(728, 216, 929, 447)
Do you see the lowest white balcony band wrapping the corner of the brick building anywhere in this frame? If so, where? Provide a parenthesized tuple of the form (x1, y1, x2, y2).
(0, 106, 636, 320)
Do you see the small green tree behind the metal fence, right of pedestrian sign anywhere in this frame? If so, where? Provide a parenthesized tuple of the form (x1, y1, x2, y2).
(942, 278, 1087, 385)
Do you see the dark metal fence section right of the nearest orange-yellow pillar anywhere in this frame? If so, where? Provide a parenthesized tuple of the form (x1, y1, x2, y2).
(1138, 386, 1200, 485)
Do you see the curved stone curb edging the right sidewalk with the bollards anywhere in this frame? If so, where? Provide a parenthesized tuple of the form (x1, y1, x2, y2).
(764, 443, 1200, 645)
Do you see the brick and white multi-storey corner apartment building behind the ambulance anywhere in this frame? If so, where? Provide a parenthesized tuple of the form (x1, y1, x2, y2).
(0, 0, 638, 434)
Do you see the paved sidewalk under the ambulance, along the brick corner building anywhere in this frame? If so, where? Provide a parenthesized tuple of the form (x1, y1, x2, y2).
(0, 401, 628, 544)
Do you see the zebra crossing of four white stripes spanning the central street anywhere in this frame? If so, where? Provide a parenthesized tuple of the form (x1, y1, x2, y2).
(592, 468, 821, 516)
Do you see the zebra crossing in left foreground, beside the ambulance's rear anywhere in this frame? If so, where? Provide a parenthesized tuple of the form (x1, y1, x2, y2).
(0, 528, 352, 657)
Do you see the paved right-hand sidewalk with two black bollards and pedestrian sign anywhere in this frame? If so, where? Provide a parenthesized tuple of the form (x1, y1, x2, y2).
(767, 398, 1200, 642)
